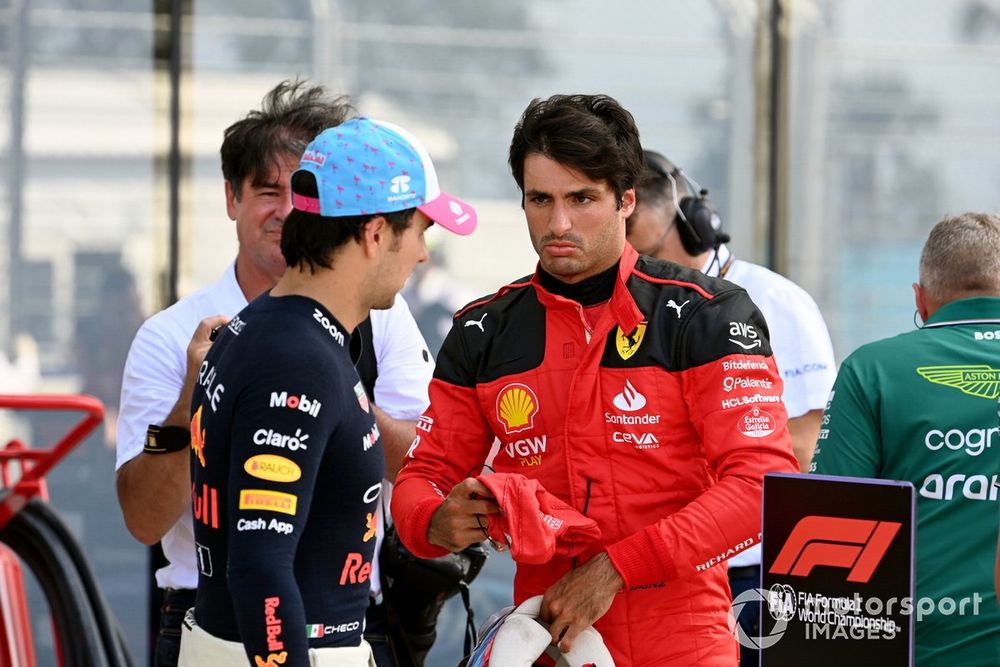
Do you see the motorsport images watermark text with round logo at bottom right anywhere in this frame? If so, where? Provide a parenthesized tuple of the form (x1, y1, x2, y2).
(729, 584, 983, 649)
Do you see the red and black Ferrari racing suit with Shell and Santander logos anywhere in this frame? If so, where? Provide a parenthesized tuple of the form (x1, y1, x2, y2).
(392, 245, 798, 667)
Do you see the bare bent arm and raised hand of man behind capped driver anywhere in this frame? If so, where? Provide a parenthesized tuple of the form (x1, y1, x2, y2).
(116, 315, 229, 544)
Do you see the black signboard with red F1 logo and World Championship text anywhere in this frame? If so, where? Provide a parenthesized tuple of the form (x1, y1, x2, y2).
(756, 473, 916, 667)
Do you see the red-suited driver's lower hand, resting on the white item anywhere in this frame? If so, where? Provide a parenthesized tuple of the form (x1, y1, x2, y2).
(540, 552, 625, 653)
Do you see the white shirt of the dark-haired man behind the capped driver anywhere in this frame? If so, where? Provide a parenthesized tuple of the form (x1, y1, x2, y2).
(115, 263, 434, 595)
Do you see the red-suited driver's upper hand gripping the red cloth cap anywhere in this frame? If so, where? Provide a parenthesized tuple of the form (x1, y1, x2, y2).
(427, 477, 500, 553)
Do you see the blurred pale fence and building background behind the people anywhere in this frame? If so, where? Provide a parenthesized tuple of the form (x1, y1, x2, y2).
(0, 0, 1000, 665)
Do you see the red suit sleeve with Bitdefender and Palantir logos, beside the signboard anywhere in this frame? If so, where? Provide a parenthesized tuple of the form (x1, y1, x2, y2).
(608, 292, 798, 588)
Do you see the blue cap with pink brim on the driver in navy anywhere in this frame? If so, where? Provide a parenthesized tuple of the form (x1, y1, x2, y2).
(292, 118, 478, 236)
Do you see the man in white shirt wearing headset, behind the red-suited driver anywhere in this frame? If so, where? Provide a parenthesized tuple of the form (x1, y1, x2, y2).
(625, 150, 837, 664)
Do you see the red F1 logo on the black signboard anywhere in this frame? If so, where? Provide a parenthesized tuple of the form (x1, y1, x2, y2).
(770, 516, 902, 584)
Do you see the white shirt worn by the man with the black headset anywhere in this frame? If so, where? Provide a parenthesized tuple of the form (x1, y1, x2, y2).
(702, 245, 837, 567)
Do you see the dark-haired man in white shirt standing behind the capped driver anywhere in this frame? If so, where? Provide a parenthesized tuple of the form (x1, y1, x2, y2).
(117, 81, 446, 667)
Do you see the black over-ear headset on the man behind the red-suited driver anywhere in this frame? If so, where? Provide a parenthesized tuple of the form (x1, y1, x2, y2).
(642, 150, 729, 256)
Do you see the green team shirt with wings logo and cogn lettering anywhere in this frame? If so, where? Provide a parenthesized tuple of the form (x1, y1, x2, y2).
(812, 297, 1000, 667)
